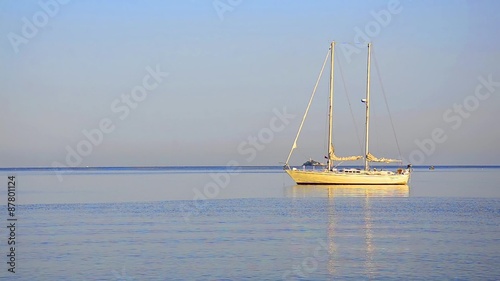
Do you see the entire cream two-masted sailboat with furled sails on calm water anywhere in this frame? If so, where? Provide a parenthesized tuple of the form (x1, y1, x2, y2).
(284, 41, 411, 185)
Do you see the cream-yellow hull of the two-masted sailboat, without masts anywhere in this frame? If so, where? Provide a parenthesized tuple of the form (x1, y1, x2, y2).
(285, 169, 410, 185)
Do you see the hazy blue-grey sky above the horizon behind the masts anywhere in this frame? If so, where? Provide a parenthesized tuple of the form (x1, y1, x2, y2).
(0, 0, 500, 167)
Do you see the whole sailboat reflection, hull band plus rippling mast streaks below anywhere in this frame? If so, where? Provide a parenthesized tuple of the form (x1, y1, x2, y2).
(285, 185, 410, 280)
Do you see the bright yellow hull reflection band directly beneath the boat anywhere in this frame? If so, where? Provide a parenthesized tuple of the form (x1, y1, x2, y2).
(285, 185, 410, 198)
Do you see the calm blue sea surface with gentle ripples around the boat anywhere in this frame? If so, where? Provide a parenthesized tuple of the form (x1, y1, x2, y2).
(0, 167, 500, 280)
